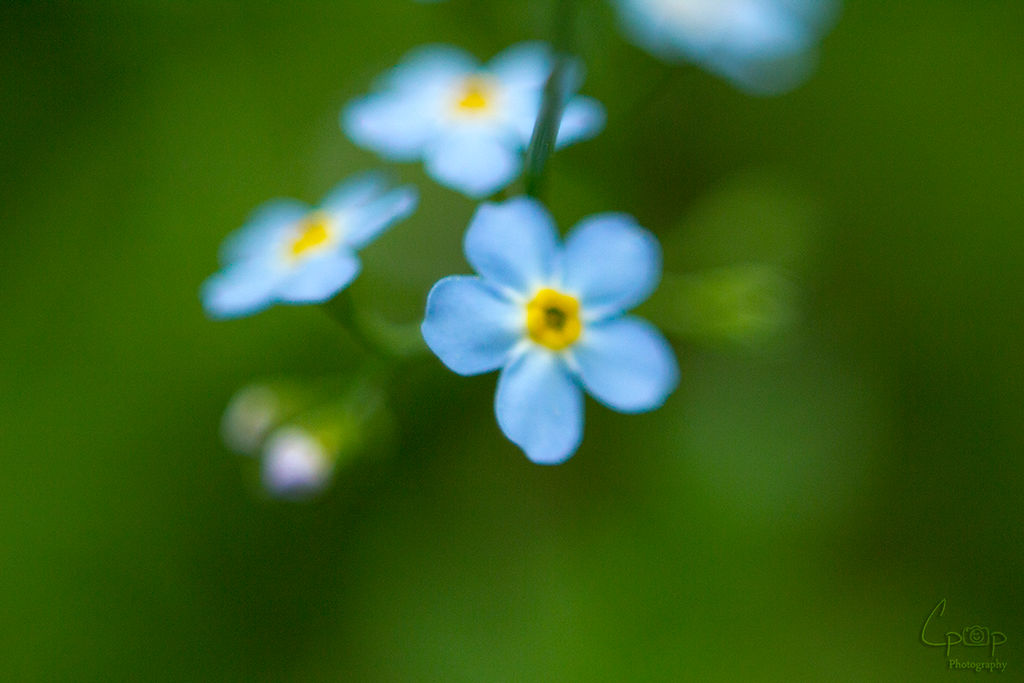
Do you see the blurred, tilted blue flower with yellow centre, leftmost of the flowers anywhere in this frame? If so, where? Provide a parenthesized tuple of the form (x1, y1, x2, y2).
(201, 173, 417, 318)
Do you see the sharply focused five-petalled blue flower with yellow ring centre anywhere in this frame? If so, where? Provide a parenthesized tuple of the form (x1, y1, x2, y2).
(423, 198, 679, 465)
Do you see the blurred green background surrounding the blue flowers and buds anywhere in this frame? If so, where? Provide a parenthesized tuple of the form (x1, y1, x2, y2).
(0, 0, 1024, 681)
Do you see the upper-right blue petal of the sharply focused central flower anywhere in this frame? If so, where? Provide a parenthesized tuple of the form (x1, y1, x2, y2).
(563, 213, 662, 318)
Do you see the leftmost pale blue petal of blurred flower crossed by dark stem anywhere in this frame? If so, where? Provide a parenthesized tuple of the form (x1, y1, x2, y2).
(341, 91, 437, 161)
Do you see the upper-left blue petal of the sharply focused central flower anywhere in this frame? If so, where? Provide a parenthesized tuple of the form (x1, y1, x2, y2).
(464, 197, 559, 296)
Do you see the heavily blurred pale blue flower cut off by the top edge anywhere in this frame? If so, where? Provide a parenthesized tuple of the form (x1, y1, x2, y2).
(615, 0, 838, 94)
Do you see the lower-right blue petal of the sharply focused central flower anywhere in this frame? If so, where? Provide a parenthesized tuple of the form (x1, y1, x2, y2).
(572, 316, 679, 413)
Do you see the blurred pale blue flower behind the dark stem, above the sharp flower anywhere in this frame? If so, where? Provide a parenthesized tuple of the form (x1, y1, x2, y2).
(341, 43, 605, 198)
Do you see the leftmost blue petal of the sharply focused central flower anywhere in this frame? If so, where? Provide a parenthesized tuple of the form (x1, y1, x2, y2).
(422, 275, 522, 375)
